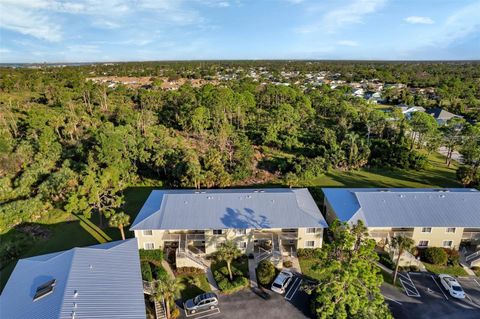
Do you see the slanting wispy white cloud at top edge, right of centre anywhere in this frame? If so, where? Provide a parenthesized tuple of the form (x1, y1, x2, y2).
(297, 0, 386, 33)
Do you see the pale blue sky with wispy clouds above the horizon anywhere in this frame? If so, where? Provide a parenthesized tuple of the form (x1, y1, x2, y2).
(0, 0, 480, 63)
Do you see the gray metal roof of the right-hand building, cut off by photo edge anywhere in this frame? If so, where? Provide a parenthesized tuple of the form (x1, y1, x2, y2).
(323, 188, 480, 227)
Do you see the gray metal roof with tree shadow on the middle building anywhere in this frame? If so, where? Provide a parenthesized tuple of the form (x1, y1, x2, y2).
(130, 188, 327, 230)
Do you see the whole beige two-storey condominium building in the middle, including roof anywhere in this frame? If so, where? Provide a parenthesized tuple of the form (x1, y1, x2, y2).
(130, 188, 327, 268)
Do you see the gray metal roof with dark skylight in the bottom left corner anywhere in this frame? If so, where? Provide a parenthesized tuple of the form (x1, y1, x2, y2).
(0, 239, 146, 319)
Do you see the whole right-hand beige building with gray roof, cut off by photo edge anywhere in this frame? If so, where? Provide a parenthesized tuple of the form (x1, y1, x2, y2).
(323, 188, 480, 249)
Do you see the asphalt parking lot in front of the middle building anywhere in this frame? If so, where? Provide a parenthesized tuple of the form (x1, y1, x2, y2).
(181, 276, 311, 319)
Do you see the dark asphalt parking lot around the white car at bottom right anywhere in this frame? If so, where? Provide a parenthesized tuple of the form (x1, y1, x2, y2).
(382, 273, 480, 319)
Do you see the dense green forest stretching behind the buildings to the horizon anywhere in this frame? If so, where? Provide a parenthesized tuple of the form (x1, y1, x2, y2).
(0, 62, 480, 232)
